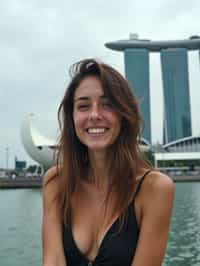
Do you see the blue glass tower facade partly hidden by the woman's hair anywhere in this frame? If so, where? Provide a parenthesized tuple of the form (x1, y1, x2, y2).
(124, 49, 151, 143)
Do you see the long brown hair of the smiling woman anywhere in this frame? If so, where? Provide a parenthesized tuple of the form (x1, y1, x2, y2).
(51, 59, 150, 228)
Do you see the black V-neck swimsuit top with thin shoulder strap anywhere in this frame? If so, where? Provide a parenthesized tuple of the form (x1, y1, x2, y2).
(63, 170, 150, 266)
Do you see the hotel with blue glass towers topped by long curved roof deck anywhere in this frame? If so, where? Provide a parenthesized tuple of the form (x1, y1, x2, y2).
(105, 34, 200, 144)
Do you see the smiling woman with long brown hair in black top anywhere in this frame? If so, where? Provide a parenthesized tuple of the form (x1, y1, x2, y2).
(43, 59, 174, 266)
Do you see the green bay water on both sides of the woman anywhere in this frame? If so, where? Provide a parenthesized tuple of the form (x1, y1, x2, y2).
(0, 183, 200, 266)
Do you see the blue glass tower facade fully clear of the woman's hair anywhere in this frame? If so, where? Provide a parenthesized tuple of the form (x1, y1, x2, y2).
(160, 48, 192, 144)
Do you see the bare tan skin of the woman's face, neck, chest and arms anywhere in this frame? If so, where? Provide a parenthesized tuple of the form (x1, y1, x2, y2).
(43, 77, 174, 266)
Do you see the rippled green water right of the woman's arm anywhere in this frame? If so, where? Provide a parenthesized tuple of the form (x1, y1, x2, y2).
(164, 183, 200, 266)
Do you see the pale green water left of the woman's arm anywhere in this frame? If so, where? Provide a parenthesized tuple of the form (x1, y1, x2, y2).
(0, 189, 42, 266)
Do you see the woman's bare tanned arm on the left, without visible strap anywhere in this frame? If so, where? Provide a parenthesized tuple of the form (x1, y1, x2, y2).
(42, 167, 66, 266)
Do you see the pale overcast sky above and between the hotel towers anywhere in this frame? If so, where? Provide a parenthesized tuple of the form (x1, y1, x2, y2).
(0, 0, 200, 167)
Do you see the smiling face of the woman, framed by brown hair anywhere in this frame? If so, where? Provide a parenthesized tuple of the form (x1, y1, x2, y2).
(73, 76, 121, 151)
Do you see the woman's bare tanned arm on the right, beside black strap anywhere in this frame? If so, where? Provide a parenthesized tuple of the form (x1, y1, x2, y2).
(133, 172, 174, 266)
